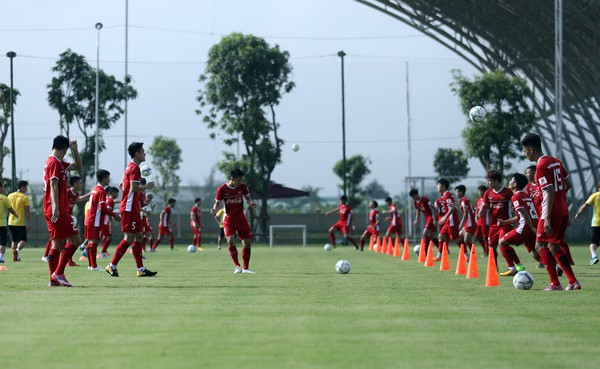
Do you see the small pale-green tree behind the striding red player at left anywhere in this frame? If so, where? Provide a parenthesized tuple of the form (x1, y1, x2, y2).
(148, 136, 182, 204)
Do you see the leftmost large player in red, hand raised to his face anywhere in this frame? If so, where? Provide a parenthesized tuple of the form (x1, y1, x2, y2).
(43, 136, 83, 287)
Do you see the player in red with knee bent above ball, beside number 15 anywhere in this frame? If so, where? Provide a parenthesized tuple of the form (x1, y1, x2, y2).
(498, 173, 540, 268)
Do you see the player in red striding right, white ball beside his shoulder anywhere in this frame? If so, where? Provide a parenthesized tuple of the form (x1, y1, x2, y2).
(105, 142, 157, 277)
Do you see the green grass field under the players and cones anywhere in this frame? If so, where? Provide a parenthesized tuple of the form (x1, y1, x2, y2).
(0, 245, 600, 369)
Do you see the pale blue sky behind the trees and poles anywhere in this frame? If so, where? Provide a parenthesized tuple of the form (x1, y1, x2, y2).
(0, 0, 484, 196)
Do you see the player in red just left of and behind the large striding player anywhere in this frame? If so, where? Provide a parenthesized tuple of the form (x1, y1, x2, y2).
(85, 169, 115, 270)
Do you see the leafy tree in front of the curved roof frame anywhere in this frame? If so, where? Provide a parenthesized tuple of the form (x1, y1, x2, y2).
(451, 70, 535, 173)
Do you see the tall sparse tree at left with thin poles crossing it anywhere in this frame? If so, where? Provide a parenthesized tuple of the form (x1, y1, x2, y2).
(47, 49, 137, 189)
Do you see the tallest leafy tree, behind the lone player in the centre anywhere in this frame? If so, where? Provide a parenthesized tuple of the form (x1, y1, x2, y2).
(197, 33, 294, 233)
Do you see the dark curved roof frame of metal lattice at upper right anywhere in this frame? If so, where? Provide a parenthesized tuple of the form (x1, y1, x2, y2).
(355, 0, 600, 198)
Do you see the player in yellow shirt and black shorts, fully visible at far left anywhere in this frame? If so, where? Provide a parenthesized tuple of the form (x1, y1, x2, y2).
(8, 181, 31, 261)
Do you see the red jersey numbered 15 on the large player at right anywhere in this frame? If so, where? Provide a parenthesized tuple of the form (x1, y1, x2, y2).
(535, 155, 569, 219)
